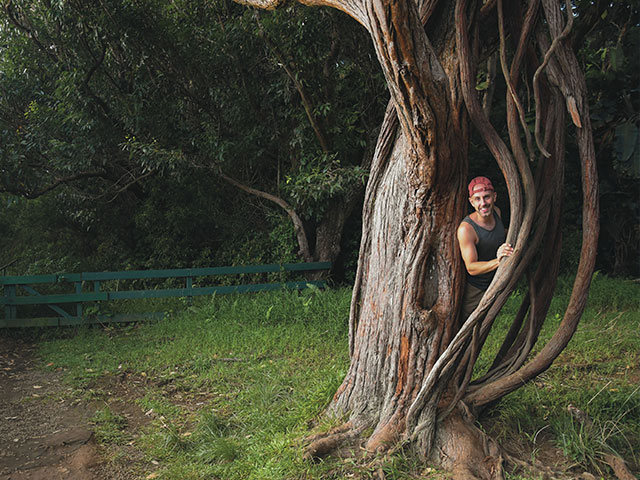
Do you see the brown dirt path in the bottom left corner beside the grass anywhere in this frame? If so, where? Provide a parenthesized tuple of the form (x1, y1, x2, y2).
(0, 338, 98, 480)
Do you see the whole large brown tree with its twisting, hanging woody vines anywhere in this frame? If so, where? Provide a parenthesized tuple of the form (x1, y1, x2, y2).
(235, 0, 599, 478)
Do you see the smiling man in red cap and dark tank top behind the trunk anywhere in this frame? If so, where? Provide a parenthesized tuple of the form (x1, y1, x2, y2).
(457, 177, 513, 322)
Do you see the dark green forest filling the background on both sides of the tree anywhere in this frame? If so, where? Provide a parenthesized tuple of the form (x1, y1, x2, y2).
(0, 0, 640, 282)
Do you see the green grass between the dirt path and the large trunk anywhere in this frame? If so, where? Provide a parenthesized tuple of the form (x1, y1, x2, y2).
(42, 289, 350, 479)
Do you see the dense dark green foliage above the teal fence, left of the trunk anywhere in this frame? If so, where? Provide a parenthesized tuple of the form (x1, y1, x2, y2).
(0, 1, 386, 273)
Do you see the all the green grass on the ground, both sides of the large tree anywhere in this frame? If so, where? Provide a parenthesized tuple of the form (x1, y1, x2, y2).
(35, 276, 640, 480)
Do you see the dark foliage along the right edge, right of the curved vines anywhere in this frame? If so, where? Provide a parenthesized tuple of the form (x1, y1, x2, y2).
(569, 0, 640, 276)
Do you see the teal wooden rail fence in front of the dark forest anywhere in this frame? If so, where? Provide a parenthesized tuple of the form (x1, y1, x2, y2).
(0, 262, 331, 328)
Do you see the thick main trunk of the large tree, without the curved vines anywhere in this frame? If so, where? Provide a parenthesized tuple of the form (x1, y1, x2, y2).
(330, 2, 486, 469)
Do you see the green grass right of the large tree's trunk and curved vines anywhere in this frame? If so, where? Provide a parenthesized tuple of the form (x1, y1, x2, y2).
(483, 275, 640, 478)
